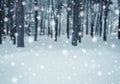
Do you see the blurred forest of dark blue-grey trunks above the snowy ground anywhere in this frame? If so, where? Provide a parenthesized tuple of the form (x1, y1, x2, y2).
(0, 0, 120, 47)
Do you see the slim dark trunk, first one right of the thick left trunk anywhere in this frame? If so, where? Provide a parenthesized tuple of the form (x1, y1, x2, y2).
(34, 0, 38, 41)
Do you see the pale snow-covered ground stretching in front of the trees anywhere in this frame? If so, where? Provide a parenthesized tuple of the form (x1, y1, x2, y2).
(0, 36, 120, 84)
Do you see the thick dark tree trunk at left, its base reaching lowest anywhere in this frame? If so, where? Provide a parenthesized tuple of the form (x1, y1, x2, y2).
(16, 0, 24, 47)
